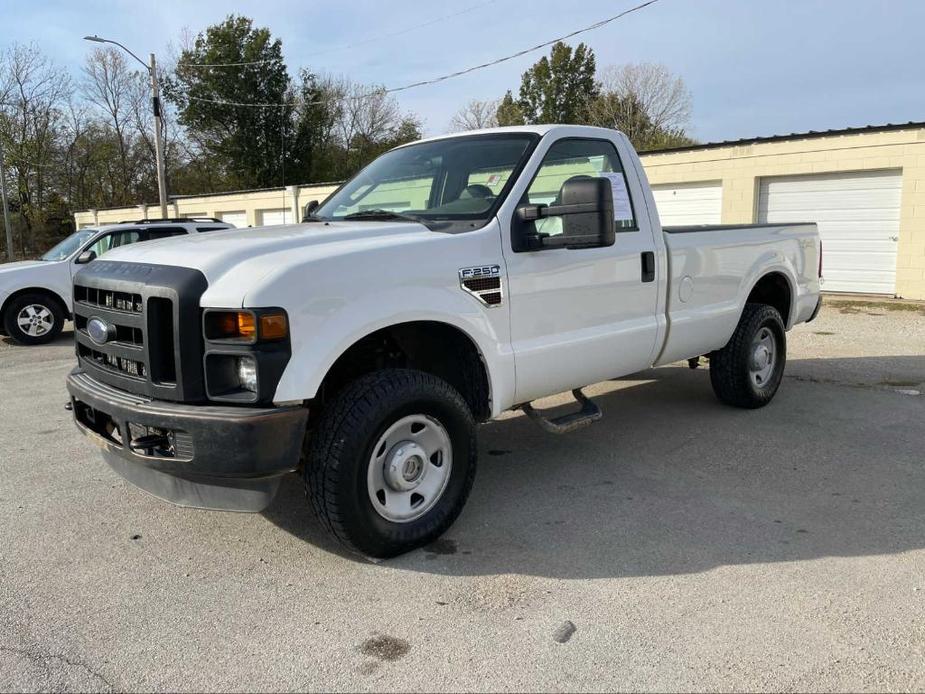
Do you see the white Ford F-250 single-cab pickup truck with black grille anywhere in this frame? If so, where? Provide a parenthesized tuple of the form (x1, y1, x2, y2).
(67, 125, 821, 557)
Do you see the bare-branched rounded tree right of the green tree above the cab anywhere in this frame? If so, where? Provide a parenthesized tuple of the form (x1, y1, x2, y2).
(587, 63, 693, 150)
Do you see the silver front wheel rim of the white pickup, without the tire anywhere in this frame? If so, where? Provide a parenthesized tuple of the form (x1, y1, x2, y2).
(366, 414, 453, 523)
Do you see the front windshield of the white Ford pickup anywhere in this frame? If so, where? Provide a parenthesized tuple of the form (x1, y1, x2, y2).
(313, 133, 539, 231)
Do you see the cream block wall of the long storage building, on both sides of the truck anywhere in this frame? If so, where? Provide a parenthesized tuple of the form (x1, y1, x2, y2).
(74, 128, 925, 299)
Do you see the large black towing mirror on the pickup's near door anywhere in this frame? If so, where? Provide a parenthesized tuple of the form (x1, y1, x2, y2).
(517, 177, 616, 250)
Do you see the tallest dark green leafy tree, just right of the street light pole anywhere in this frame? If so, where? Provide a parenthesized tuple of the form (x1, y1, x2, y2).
(164, 15, 294, 188)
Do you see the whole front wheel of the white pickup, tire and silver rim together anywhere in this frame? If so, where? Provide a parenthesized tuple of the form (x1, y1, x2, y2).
(304, 369, 476, 558)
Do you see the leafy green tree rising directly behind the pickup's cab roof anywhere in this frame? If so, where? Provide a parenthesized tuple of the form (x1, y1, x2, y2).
(518, 41, 598, 124)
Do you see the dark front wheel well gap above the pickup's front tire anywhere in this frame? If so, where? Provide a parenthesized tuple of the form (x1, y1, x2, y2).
(309, 321, 491, 421)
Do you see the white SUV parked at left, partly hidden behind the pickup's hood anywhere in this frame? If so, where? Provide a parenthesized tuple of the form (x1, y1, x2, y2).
(0, 217, 234, 345)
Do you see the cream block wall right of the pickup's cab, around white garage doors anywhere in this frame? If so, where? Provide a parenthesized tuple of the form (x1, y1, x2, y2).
(642, 128, 925, 299)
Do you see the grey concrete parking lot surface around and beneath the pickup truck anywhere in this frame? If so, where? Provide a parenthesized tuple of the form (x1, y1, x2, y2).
(0, 301, 925, 691)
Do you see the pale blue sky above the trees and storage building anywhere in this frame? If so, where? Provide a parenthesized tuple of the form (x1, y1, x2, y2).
(0, 0, 925, 142)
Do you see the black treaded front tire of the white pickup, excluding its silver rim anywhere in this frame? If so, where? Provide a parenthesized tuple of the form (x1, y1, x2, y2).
(303, 369, 477, 558)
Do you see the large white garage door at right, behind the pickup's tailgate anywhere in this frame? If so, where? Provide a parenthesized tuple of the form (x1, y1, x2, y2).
(758, 171, 902, 294)
